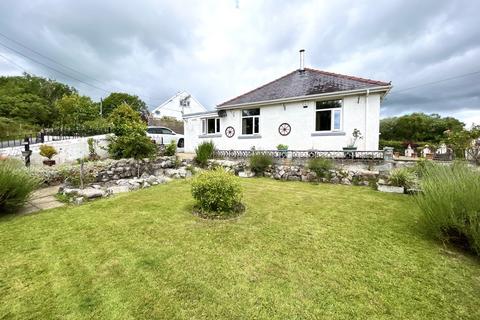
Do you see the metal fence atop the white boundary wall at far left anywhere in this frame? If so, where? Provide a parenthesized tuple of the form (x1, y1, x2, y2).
(0, 127, 111, 149)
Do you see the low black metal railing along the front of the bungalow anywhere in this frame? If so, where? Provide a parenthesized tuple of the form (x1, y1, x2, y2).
(214, 150, 385, 160)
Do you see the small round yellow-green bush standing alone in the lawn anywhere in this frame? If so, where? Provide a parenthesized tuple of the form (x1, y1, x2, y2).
(192, 168, 243, 219)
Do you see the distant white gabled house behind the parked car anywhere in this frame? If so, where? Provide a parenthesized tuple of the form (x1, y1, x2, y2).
(152, 91, 207, 120)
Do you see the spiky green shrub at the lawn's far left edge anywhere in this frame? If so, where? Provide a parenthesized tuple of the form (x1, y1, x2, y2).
(0, 160, 40, 213)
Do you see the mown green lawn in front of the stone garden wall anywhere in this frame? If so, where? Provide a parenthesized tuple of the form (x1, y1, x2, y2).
(0, 179, 480, 319)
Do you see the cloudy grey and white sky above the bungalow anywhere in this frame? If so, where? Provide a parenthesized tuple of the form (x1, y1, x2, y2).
(0, 0, 480, 125)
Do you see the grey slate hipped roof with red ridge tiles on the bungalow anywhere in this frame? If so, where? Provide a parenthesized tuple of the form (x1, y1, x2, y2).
(217, 68, 390, 108)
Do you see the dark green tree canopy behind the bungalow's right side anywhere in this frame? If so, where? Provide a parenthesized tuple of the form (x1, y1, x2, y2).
(380, 113, 465, 143)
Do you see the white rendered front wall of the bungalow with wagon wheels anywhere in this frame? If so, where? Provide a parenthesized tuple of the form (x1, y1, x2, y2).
(185, 94, 380, 152)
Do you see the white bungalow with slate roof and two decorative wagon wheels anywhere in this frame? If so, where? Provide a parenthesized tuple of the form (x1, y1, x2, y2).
(183, 51, 392, 152)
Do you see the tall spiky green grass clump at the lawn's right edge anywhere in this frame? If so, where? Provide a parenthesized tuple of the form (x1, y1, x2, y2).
(416, 164, 480, 255)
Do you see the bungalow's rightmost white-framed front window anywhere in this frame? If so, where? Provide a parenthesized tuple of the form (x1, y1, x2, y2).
(315, 100, 342, 131)
